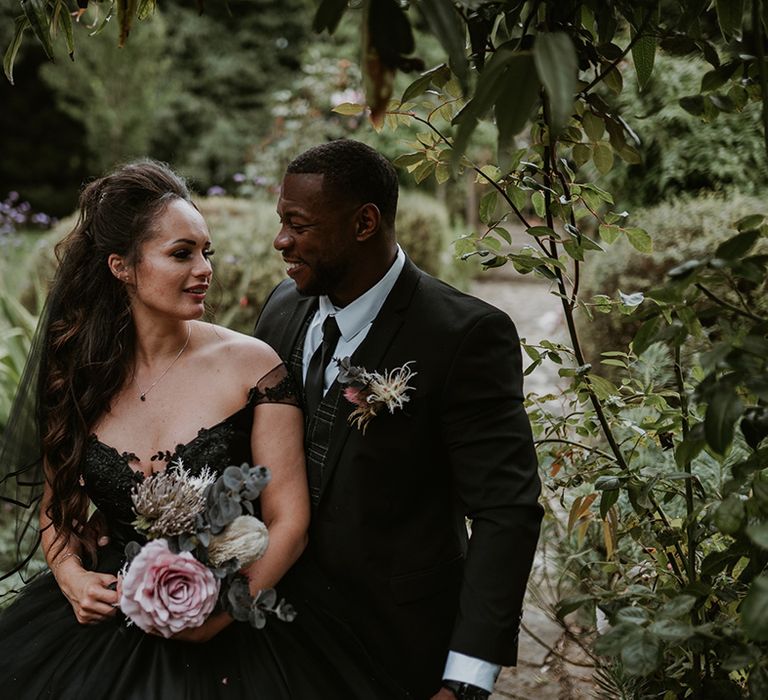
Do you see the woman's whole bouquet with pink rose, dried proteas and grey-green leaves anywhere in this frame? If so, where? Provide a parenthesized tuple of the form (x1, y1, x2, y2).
(119, 460, 295, 637)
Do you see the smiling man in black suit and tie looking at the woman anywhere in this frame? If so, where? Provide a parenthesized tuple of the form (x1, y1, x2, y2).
(255, 140, 542, 700)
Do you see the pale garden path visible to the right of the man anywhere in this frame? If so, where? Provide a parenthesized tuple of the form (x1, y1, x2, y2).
(471, 265, 595, 700)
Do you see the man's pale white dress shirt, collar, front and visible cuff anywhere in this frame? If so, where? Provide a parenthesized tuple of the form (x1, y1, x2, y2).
(303, 246, 500, 691)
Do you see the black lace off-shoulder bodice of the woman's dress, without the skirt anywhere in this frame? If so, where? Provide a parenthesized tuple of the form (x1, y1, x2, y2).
(82, 364, 298, 542)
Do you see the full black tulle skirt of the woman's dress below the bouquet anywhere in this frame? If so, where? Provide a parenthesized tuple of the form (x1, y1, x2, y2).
(0, 548, 403, 700)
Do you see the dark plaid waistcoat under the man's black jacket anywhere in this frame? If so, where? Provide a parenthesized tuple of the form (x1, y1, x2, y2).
(289, 314, 341, 508)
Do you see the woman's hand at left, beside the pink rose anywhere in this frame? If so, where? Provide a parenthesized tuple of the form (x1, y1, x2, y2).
(54, 558, 118, 625)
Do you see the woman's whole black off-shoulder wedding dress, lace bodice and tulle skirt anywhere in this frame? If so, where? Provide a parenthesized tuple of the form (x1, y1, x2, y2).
(0, 366, 402, 700)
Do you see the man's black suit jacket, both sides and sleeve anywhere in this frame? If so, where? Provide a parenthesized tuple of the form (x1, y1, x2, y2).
(256, 260, 542, 700)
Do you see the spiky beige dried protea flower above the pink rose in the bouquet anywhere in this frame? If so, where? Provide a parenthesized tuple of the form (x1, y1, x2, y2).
(131, 460, 216, 539)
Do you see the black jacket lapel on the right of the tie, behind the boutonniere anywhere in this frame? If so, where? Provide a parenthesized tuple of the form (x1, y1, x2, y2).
(320, 258, 421, 502)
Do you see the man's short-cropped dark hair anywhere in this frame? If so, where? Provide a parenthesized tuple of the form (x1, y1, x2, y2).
(285, 139, 397, 227)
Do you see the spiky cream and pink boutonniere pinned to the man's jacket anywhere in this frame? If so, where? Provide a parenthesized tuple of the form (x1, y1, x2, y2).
(334, 357, 416, 435)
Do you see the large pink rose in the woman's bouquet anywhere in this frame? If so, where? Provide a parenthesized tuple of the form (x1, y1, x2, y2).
(120, 539, 219, 638)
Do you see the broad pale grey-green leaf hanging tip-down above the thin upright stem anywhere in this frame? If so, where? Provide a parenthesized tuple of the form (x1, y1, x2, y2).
(533, 32, 578, 134)
